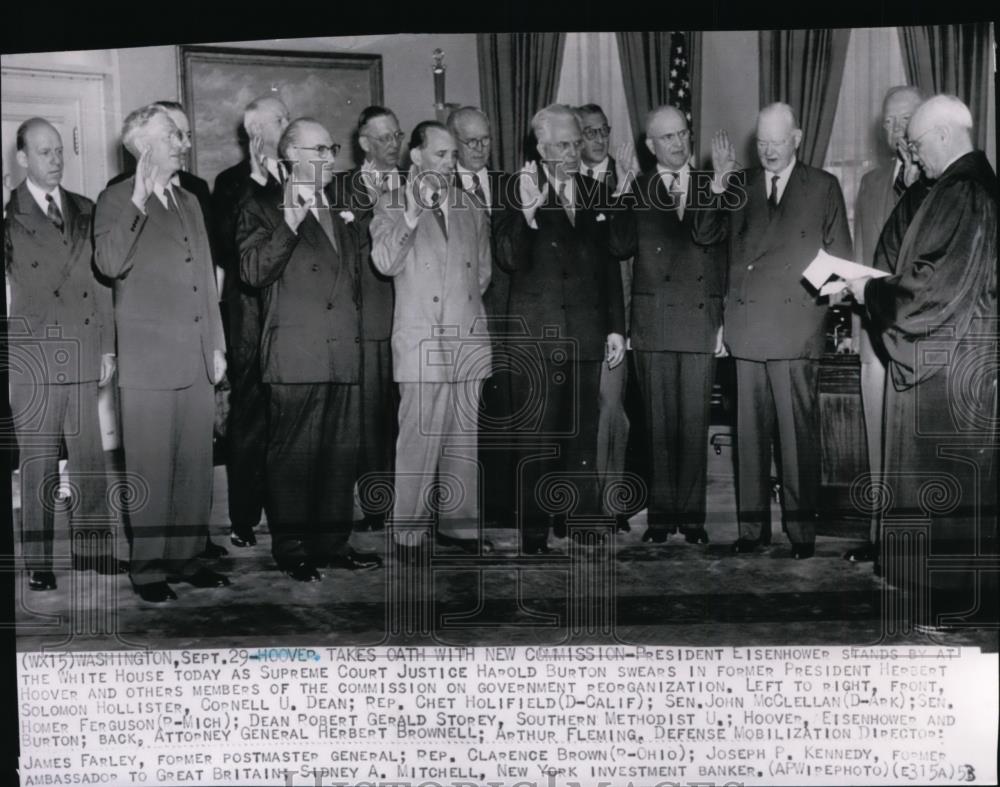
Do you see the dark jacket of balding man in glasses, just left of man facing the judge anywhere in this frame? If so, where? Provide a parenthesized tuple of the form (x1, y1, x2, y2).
(617, 170, 728, 353)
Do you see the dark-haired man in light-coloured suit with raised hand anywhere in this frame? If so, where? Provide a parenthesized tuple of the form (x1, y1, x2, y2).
(371, 121, 493, 561)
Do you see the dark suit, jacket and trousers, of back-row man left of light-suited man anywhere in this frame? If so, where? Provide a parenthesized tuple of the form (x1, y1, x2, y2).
(331, 167, 399, 526)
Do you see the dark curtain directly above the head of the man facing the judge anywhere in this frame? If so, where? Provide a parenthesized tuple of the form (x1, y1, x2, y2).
(760, 29, 851, 167)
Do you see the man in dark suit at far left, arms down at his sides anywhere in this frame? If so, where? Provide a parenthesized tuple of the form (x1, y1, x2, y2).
(4, 117, 118, 590)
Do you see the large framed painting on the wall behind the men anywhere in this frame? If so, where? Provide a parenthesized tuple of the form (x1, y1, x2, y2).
(179, 46, 382, 184)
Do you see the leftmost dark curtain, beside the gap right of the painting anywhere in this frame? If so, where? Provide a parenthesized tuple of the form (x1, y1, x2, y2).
(476, 33, 565, 172)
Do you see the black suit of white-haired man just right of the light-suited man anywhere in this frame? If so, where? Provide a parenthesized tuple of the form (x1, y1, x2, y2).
(498, 170, 625, 543)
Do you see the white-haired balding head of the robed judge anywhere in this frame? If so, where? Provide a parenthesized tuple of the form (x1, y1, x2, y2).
(906, 94, 973, 179)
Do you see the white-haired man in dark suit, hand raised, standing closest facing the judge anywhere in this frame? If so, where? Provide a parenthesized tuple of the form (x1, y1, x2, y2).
(694, 103, 851, 559)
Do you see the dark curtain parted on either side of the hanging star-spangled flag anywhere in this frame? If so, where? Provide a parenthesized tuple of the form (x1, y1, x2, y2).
(616, 30, 701, 164)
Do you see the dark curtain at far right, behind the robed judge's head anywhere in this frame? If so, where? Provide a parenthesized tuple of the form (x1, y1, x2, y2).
(899, 23, 993, 150)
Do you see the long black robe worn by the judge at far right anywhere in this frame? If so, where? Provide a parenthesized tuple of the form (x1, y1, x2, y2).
(865, 151, 998, 624)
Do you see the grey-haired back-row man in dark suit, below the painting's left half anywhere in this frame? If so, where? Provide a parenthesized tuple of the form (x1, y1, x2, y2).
(212, 96, 288, 547)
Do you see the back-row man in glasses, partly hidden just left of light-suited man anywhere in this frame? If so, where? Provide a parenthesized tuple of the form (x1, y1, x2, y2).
(331, 106, 403, 530)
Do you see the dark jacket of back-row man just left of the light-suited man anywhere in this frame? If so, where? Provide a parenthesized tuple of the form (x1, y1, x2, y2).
(330, 167, 394, 341)
